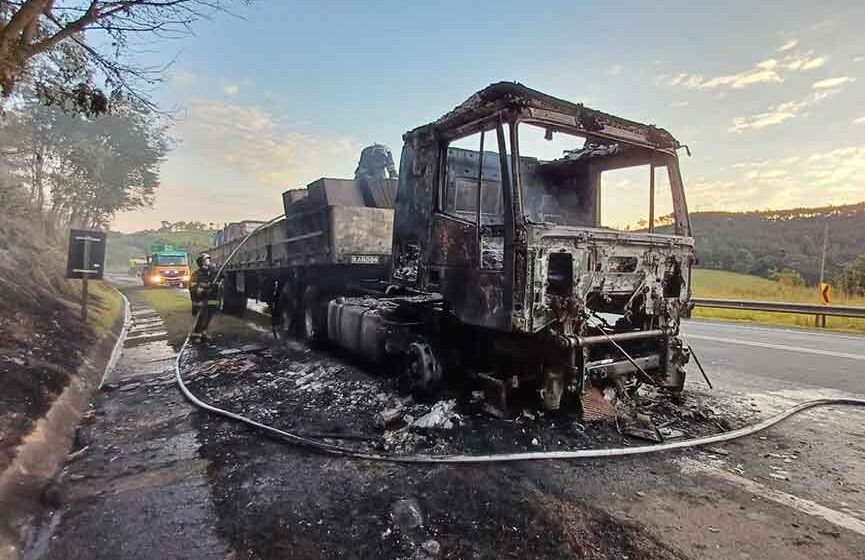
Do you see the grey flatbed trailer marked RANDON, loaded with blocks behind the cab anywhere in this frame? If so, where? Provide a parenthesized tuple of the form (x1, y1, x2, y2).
(211, 178, 396, 330)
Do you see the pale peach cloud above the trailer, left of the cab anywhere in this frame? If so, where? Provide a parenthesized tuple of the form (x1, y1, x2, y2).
(176, 100, 360, 188)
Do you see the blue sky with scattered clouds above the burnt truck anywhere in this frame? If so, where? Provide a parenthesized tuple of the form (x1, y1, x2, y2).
(112, 0, 865, 231)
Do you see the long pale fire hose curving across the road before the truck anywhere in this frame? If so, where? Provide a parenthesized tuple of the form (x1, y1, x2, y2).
(174, 214, 865, 464)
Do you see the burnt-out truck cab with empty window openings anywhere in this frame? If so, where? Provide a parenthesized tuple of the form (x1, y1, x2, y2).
(390, 82, 694, 409)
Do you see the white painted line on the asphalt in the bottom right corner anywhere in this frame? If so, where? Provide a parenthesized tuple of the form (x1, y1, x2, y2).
(679, 459, 865, 535)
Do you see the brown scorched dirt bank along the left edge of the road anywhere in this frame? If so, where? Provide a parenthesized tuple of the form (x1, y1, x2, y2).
(0, 212, 119, 472)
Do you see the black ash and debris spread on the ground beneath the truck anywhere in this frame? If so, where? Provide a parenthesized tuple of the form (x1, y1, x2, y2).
(183, 344, 748, 454)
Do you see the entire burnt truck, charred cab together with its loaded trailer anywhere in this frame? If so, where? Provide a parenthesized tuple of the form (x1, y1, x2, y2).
(211, 83, 694, 416)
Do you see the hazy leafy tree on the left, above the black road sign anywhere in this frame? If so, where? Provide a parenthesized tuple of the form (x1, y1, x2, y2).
(2, 86, 170, 228)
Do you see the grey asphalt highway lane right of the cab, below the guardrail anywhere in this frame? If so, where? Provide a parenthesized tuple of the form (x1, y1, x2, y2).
(682, 320, 865, 395)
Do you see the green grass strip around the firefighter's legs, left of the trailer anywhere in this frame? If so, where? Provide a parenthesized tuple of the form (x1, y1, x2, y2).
(135, 286, 270, 348)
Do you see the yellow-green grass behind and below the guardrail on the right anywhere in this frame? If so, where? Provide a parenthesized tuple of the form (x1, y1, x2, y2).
(693, 269, 865, 332)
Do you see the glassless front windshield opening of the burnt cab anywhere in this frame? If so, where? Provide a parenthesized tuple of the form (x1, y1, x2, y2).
(512, 118, 689, 235)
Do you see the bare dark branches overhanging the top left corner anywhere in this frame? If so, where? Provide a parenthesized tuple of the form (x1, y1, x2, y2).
(0, 0, 249, 114)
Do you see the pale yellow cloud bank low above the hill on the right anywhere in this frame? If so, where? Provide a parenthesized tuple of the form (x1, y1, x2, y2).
(687, 145, 865, 210)
